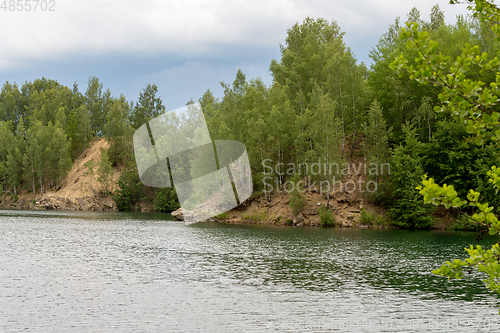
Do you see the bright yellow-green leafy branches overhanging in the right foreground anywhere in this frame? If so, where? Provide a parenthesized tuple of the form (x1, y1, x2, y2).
(391, 0, 500, 313)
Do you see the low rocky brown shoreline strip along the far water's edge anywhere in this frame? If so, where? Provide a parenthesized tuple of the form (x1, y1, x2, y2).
(0, 190, 451, 230)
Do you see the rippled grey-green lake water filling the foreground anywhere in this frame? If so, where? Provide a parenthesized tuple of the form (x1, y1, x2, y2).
(0, 210, 500, 332)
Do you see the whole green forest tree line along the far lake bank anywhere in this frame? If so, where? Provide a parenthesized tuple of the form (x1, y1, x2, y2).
(0, 6, 500, 228)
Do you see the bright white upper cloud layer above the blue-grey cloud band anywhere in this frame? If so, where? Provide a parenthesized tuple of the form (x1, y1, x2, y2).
(0, 0, 465, 70)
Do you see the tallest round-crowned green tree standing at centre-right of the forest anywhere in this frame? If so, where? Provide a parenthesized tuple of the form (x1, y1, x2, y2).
(270, 18, 364, 162)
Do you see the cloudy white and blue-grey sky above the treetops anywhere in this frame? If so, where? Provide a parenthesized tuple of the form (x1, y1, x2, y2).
(0, 0, 469, 110)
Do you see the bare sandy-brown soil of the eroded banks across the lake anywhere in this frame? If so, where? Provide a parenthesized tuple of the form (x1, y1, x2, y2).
(0, 134, 453, 229)
